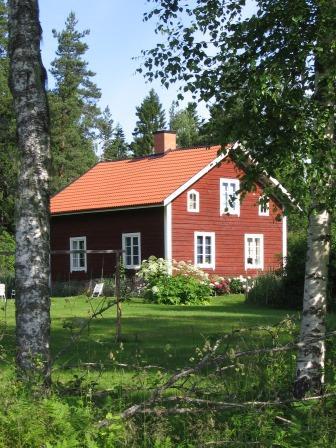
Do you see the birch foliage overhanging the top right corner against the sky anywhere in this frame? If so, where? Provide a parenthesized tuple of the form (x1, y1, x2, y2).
(145, 0, 336, 212)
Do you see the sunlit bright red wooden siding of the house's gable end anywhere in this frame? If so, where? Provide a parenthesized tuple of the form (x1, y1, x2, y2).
(172, 159, 282, 276)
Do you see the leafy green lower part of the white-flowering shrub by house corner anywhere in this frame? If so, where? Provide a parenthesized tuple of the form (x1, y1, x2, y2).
(145, 275, 211, 305)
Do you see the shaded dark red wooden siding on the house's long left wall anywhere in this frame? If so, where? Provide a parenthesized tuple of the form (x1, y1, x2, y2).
(51, 207, 164, 281)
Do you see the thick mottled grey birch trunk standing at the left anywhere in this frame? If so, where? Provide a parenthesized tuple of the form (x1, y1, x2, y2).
(9, 0, 50, 384)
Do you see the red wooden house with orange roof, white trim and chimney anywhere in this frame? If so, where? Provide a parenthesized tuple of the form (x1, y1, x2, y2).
(51, 131, 287, 280)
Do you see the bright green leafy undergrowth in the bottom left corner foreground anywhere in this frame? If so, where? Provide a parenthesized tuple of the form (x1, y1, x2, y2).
(0, 374, 124, 448)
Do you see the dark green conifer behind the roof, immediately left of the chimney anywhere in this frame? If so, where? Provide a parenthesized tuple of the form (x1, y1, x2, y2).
(131, 89, 166, 156)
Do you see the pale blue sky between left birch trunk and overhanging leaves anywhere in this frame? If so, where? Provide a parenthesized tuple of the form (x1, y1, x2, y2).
(40, 0, 200, 141)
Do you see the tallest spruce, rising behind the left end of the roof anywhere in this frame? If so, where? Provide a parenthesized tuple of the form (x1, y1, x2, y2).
(49, 12, 101, 192)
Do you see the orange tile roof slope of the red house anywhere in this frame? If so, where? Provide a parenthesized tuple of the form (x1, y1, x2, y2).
(51, 146, 220, 214)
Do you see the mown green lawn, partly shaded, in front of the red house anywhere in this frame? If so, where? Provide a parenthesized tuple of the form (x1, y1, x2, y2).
(2, 295, 293, 387)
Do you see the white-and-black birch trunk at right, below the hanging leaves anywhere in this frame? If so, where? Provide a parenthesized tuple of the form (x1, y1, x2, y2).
(294, 210, 331, 398)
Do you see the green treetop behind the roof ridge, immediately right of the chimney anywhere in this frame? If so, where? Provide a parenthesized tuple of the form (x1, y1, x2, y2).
(169, 102, 200, 147)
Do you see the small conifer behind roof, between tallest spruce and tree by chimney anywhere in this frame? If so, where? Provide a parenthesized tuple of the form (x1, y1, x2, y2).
(99, 107, 129, 160)
